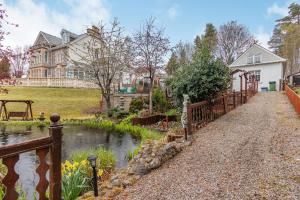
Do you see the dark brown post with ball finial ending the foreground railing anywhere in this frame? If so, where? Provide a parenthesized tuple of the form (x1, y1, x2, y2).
(49, 114, 63, 200)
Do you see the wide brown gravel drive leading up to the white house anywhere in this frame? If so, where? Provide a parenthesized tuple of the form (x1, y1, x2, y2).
(117, 92, 300, 200)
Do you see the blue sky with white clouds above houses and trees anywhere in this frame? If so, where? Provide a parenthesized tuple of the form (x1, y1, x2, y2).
(0, 0, 300, 48)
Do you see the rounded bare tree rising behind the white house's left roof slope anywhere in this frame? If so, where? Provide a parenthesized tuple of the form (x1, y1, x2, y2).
(217, 21, 255, 65)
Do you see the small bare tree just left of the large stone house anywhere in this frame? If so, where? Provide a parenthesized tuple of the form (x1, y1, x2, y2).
(9, 46, 29, 78)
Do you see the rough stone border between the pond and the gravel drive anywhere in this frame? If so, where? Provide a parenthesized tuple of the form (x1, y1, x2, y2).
(78, 139, 191, 200)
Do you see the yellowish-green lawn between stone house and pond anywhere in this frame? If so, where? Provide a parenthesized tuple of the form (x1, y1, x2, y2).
(0, 87, 101, 119)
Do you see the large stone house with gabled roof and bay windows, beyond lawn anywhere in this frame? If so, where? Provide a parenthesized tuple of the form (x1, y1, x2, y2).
(29, 27, 97, 79)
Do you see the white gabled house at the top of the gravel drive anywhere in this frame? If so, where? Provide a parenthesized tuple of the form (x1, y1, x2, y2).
(229, 44, 286, 91)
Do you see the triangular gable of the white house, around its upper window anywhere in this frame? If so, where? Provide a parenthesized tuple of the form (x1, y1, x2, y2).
(229, 44, 286, 67)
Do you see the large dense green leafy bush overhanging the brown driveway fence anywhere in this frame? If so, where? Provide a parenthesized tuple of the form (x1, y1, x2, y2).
(167, 43, 230, 106)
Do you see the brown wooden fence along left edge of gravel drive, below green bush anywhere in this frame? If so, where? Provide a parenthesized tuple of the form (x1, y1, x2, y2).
(187, 82, 257, 134)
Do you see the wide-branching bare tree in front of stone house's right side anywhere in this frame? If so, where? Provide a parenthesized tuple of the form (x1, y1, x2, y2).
(70, 19, 132, 109)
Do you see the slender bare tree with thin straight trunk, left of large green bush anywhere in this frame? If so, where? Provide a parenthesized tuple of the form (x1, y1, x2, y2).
(134, 18, 170, 114)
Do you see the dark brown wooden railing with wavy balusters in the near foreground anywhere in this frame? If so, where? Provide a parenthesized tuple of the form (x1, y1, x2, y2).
(0, 114, 62, 200)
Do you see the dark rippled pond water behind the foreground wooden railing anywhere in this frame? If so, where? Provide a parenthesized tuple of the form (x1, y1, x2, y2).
(0, 126, 140, 199)
